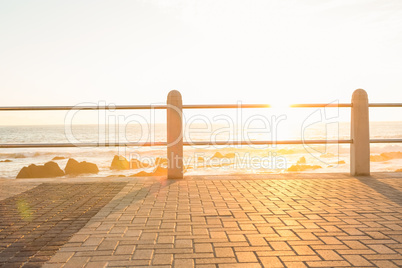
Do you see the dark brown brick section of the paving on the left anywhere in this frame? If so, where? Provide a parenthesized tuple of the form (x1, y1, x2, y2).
(0, 182, 126, 267)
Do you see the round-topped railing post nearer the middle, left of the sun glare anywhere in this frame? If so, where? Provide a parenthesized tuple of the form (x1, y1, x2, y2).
(166, 90, 183, 179)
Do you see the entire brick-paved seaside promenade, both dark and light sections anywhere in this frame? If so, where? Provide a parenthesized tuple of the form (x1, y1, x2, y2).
(0, 173, 402, 268)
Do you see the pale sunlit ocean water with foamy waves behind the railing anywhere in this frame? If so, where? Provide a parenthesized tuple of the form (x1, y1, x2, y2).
(0, 121, 402, 179)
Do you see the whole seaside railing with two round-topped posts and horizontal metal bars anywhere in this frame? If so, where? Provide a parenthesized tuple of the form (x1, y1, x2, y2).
(0, 89, 402, 179)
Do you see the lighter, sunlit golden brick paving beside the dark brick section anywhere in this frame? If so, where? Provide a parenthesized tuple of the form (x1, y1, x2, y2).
(0, 173, 402, 267)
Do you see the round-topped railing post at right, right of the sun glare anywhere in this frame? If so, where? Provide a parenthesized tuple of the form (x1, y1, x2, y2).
(350, 89, 370, 176)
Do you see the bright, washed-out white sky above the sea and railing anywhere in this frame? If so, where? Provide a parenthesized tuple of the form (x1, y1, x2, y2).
(0, 0, 402, 125)
